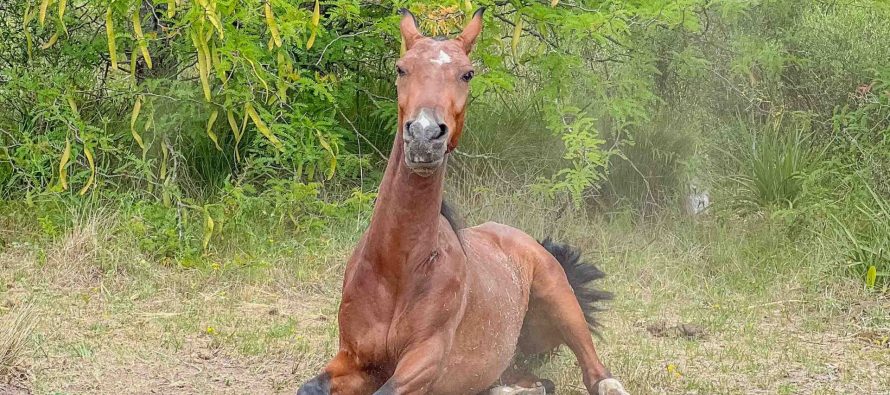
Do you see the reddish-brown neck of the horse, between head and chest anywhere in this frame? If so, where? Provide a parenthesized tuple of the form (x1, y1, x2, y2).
(364, 135, 445, 274)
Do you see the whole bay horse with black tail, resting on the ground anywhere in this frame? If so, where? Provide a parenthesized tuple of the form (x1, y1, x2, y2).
(297, 9, 627, 395)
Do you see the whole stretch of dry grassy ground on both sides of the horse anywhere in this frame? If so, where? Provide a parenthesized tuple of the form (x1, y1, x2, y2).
(0, 178, 890, 394)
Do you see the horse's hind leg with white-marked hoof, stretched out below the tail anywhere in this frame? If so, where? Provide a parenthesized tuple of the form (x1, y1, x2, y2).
(532, 262, 627, 395)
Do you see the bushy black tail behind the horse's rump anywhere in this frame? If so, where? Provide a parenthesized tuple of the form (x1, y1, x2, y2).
(541, 237, 612, 331)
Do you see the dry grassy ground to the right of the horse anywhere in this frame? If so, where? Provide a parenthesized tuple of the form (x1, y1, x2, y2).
(449, 174, 890, 394)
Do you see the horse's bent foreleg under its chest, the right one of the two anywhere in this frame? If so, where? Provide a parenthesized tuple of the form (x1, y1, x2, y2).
(374, 335, 449, 395)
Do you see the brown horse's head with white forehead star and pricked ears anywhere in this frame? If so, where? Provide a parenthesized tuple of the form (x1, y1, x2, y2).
(396, 8, 485, 176)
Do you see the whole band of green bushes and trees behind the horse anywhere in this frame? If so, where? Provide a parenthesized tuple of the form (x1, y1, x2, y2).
(0, 0, 890, 296)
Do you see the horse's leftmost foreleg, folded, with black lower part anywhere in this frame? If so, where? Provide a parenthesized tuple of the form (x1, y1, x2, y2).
(297, 351, 379, 395)
